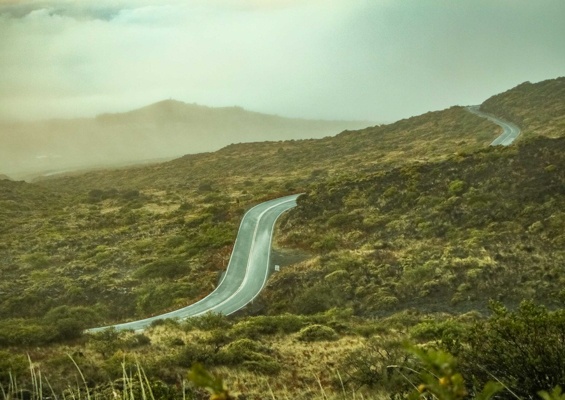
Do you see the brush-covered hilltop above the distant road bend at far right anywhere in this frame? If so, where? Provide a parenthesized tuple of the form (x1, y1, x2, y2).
(481, 77, 565, 137)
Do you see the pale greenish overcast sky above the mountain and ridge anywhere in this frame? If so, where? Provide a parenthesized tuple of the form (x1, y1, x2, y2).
(0, 0, 565, 122)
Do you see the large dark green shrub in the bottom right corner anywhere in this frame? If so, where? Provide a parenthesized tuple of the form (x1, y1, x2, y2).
(445, 301, 565, 398)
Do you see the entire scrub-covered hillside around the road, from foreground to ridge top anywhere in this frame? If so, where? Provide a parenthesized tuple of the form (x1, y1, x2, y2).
(0, 77, 565, 400)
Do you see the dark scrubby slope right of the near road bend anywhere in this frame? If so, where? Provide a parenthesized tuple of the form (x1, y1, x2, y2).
(263, 138, 565, 316)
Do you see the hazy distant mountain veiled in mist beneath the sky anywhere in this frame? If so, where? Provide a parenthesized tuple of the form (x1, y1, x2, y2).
(0, 100, 370, 179)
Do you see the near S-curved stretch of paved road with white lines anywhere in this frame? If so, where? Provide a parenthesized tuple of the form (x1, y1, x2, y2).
(87, 195, 299, 332)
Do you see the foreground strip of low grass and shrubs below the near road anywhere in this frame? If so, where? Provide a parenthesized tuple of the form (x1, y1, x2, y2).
(0, 302, 565, 399)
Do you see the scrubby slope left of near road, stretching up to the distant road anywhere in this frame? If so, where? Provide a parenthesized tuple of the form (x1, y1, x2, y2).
(0, 103, 496, 332)
